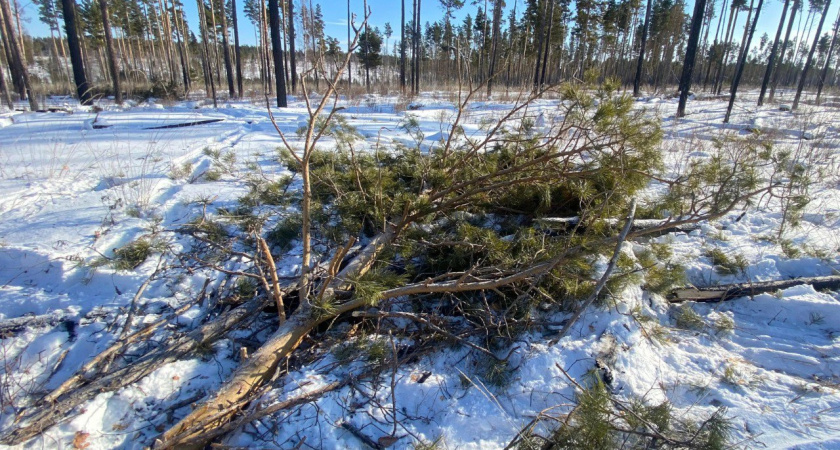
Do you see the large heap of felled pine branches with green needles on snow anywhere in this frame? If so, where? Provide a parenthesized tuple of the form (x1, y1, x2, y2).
(0, 27, 800, 448)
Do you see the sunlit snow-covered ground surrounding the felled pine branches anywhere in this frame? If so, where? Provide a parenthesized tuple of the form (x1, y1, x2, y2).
(0, 89, 840, 449)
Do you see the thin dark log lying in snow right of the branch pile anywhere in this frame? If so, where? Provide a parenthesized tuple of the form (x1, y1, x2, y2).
(668, 275, 840, 303)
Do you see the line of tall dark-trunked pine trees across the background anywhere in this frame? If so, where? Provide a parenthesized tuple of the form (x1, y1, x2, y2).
(0, 0, 840, 107)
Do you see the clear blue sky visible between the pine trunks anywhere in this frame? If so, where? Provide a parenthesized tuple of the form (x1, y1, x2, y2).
(18, 0, 840, 52)
